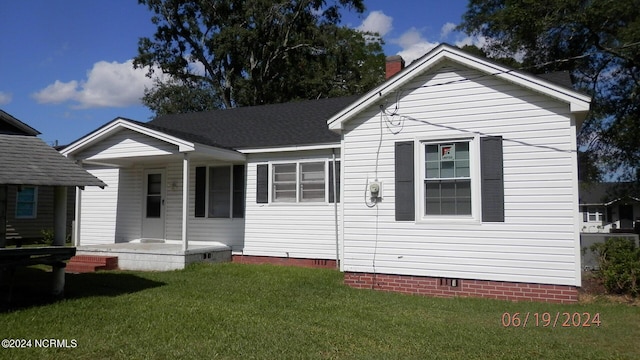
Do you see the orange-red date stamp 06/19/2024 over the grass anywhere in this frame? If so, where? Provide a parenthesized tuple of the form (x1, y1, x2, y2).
(500, 311, 602, 328)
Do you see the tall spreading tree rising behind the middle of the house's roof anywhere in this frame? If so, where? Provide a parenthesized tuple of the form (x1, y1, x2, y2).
(134, 0, 384, 112)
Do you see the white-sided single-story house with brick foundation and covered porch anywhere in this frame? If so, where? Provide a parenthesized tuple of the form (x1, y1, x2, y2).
(62, 45, 590, 302)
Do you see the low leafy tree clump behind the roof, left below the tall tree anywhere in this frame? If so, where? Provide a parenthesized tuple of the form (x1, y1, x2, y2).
(142, 79, 220, 116)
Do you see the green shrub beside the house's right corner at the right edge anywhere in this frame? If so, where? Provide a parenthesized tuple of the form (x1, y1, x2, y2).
(591, 237, 640, 296)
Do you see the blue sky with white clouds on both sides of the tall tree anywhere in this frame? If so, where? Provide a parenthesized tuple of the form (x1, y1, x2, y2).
(0, 0, 478, 144)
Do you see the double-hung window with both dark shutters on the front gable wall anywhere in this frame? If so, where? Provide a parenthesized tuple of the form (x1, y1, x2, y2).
(394, 136, 505, 222)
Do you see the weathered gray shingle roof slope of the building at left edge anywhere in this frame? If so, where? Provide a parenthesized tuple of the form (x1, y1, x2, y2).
(0, 134, 106, 186)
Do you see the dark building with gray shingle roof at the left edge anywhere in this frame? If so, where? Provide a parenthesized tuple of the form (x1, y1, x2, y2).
(0, 110, 105, 298)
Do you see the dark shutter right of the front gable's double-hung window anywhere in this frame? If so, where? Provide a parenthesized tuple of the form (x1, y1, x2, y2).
(480, 136, 504, 222)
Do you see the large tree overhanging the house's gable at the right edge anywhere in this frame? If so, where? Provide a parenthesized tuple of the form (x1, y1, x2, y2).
(459, 0, 640, 182)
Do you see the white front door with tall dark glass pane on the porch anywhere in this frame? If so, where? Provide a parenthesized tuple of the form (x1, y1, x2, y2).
(142, 169, 165, 240)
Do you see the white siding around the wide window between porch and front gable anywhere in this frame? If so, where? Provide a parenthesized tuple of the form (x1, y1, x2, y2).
(243, 150, 340, 259)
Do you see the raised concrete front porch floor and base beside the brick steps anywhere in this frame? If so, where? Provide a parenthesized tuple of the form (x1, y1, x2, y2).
(76, 242, 231, 271)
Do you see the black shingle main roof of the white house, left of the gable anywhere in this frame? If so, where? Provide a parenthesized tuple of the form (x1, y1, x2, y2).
(148, 96, 358, 149)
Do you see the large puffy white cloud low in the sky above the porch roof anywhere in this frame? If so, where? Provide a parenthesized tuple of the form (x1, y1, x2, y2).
(33, 60, 162, 109)
